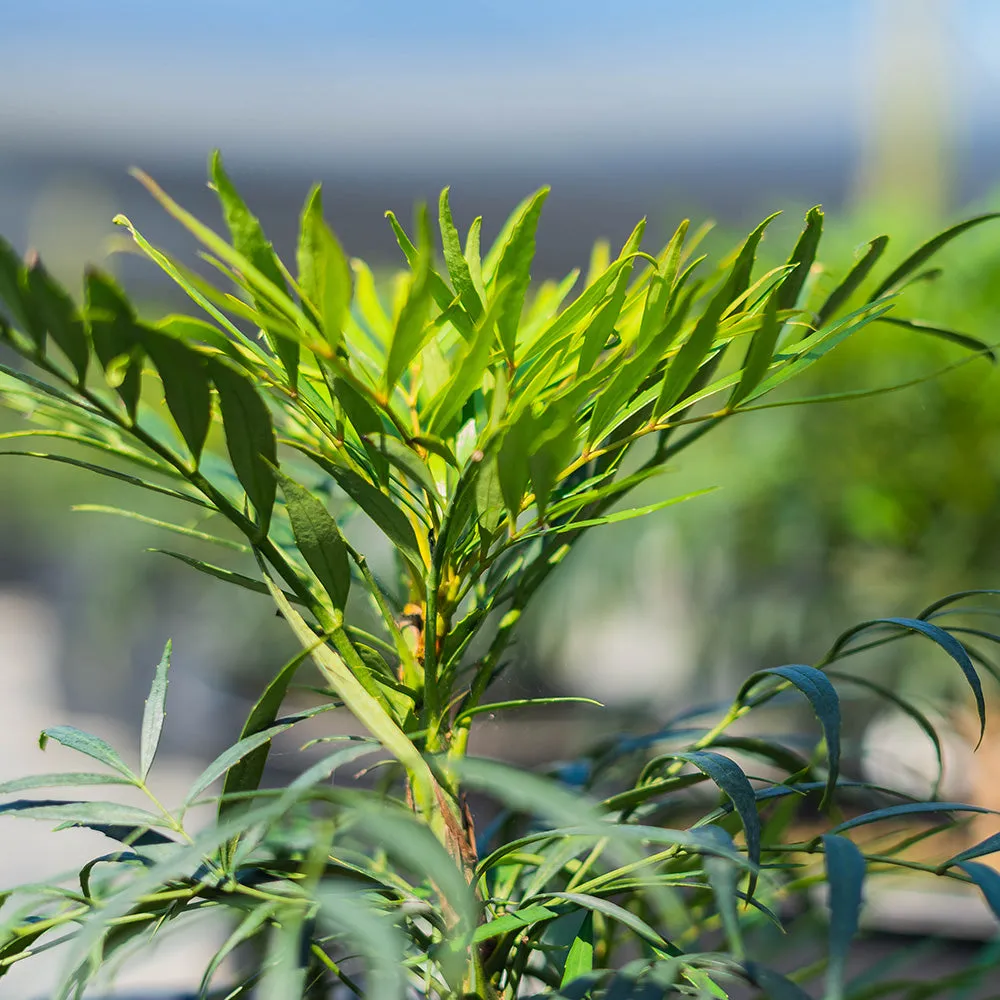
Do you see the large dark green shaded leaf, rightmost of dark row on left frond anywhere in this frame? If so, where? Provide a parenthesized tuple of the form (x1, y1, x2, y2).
(211, 359, 278, 537)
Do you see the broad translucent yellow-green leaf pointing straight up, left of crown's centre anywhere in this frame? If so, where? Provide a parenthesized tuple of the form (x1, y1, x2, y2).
(298, 184, 353, 348)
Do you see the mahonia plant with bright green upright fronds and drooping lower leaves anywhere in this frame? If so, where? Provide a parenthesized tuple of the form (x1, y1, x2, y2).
(0, 154, 1000, 1000)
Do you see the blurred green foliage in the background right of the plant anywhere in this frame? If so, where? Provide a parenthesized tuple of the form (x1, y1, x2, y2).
(538, 196, 1000, 699)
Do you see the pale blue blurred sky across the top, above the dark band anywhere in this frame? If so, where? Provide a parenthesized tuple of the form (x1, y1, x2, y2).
(0, 0, 1000, 169)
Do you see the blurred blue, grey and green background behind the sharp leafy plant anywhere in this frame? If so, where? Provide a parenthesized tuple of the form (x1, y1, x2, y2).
(0, 0, 1000, 992)
